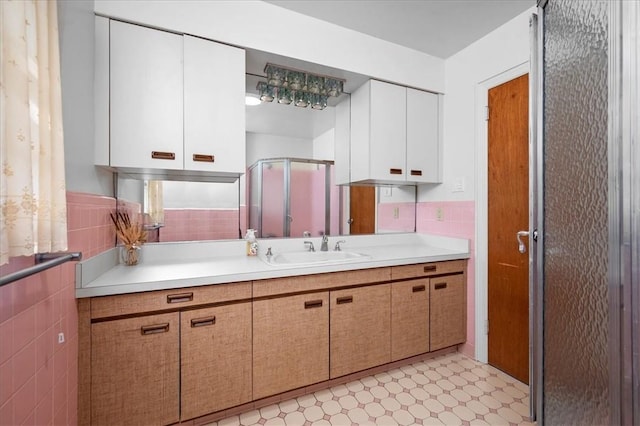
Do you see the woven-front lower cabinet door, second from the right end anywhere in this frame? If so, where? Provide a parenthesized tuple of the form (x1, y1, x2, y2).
(391, 278, 429, 361)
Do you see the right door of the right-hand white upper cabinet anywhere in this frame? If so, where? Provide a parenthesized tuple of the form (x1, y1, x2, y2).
(407, 89, 441, 182)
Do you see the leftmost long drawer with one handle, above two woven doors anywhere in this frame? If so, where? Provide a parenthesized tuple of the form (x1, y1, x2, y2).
(91, 282, 251, 319)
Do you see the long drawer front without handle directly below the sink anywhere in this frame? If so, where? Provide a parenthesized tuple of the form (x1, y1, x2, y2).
(253, 268, 391, 297)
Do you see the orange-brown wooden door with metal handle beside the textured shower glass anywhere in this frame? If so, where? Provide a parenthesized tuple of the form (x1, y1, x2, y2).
(488, 75, 529, 383)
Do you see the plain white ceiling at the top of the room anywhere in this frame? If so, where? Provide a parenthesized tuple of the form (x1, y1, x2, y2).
(267, 0, 536, 59)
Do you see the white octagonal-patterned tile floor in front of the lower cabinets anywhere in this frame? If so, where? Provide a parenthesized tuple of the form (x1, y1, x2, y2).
(208, 353, 533, 426)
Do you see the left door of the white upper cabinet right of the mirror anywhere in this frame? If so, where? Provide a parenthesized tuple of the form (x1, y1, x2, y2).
(369, 80, 407, 181)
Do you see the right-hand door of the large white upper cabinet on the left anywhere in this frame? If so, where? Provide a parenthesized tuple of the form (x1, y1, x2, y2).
(184, 36, 246, 173)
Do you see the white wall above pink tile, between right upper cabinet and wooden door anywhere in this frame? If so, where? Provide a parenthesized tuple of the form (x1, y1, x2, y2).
(418, 8, 535, 201)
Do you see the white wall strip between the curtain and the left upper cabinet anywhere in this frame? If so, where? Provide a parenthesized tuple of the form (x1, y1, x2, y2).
(58, 0, 113, 196)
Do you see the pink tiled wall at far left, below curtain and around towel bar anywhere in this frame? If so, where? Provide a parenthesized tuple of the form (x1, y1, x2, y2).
(0, 192, 115, 425)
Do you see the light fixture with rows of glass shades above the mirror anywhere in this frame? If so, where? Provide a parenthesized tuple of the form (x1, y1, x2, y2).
(256, 64, 345, 110)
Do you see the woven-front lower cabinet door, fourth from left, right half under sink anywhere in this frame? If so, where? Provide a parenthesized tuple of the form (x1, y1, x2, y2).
(330, 284, 391, 378)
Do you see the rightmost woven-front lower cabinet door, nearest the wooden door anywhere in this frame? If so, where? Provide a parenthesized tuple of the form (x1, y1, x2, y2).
(429, 274, 467, 351)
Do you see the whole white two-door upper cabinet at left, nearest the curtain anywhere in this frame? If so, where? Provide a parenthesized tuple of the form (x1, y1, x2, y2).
(95, 17, 246, 178)
